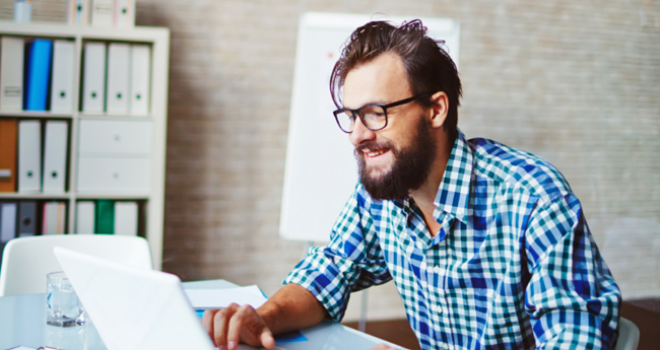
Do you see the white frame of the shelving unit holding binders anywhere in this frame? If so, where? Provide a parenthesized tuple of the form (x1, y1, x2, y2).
(0, 21, 170, 270)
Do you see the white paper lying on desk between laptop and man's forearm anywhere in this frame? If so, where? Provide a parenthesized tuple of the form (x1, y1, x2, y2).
(185, 285, 268, 309)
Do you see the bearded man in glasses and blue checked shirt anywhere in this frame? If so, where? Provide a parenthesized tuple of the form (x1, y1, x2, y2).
(203, 20, 621, 349)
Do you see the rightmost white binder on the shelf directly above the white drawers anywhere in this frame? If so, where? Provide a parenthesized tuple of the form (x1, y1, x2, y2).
(129, 45, 151, 116)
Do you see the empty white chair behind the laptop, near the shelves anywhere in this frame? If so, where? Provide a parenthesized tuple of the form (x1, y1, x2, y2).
(0, 235, 151, 296)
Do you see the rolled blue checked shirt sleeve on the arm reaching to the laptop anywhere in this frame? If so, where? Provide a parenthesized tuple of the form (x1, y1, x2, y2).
(283, 185, 392, 322)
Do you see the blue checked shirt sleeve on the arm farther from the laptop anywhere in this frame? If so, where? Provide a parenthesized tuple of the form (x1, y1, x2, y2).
(525, 194, 621, 349)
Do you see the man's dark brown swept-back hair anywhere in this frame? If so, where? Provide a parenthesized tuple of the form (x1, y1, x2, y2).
(330, 19, 461, 139)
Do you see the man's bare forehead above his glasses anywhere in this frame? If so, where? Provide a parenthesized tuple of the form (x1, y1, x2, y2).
(343, 53, 411, 108)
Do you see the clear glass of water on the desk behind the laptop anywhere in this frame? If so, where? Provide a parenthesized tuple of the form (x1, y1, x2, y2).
(46, 272, 86, 327)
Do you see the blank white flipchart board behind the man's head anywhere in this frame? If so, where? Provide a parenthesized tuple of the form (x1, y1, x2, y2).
(280, 12, 459, 242)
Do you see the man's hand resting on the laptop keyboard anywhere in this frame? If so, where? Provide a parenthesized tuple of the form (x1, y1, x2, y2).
(202, 303, 275, 350)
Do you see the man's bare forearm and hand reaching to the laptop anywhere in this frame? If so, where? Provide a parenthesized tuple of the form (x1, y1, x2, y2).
(202, 283, 327, 350)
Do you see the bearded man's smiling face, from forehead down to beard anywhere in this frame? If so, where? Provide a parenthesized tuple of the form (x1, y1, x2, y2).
(344, 53, 436, 199)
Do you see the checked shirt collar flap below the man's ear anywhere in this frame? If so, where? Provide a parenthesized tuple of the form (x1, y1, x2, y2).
(433, 129, 474, 223)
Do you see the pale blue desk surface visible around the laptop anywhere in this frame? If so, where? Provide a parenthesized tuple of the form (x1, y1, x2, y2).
(0, 280, 402, 350)
